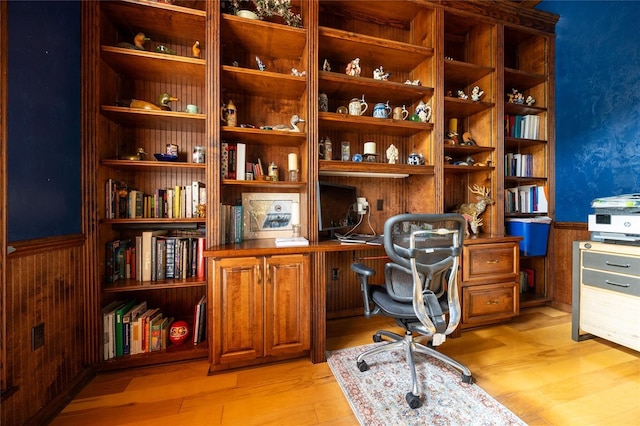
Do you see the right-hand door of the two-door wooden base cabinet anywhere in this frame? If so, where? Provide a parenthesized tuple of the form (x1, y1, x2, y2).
(265, 255, 311, 356)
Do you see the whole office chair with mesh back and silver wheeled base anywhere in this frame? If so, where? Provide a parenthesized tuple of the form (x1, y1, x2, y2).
(351, 213, 472, 408)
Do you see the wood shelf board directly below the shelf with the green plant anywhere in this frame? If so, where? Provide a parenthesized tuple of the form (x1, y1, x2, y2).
(220, 65, 307, 100)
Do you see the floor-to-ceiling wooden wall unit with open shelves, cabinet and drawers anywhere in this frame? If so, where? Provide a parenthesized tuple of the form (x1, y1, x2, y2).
(83, 0, 557, 368)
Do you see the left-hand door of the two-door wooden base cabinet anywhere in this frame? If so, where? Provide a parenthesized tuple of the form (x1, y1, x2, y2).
(211, 257, 264, 364)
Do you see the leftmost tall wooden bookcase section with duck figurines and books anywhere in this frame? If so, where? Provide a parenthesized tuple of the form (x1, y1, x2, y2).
(90, 0, 209, 368)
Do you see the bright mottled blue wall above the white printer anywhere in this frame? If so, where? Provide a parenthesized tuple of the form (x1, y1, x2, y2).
(537, 0, 640, 222)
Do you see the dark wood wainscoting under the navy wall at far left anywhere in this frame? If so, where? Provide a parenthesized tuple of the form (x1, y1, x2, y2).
(0, 235, 95, 425)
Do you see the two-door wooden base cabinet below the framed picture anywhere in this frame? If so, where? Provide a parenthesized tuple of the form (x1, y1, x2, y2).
(209, 254, 311, 372)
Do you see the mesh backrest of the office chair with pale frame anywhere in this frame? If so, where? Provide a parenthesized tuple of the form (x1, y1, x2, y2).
(384, 213, 467, 335)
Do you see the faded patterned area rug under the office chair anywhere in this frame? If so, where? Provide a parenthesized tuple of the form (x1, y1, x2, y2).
(327, 343, 525, 426)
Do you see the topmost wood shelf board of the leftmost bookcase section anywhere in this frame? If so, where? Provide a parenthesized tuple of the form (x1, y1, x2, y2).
(100, 0, 206, 46)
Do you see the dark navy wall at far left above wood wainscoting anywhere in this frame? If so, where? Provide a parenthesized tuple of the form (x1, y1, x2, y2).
(7, 0, 82, 241)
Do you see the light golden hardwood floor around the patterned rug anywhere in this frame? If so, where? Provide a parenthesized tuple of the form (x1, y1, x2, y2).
(52, 307, 640, 426)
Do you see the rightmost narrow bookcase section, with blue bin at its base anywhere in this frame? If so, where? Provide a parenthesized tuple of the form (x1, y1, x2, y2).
(501, 25, 555, 306)
